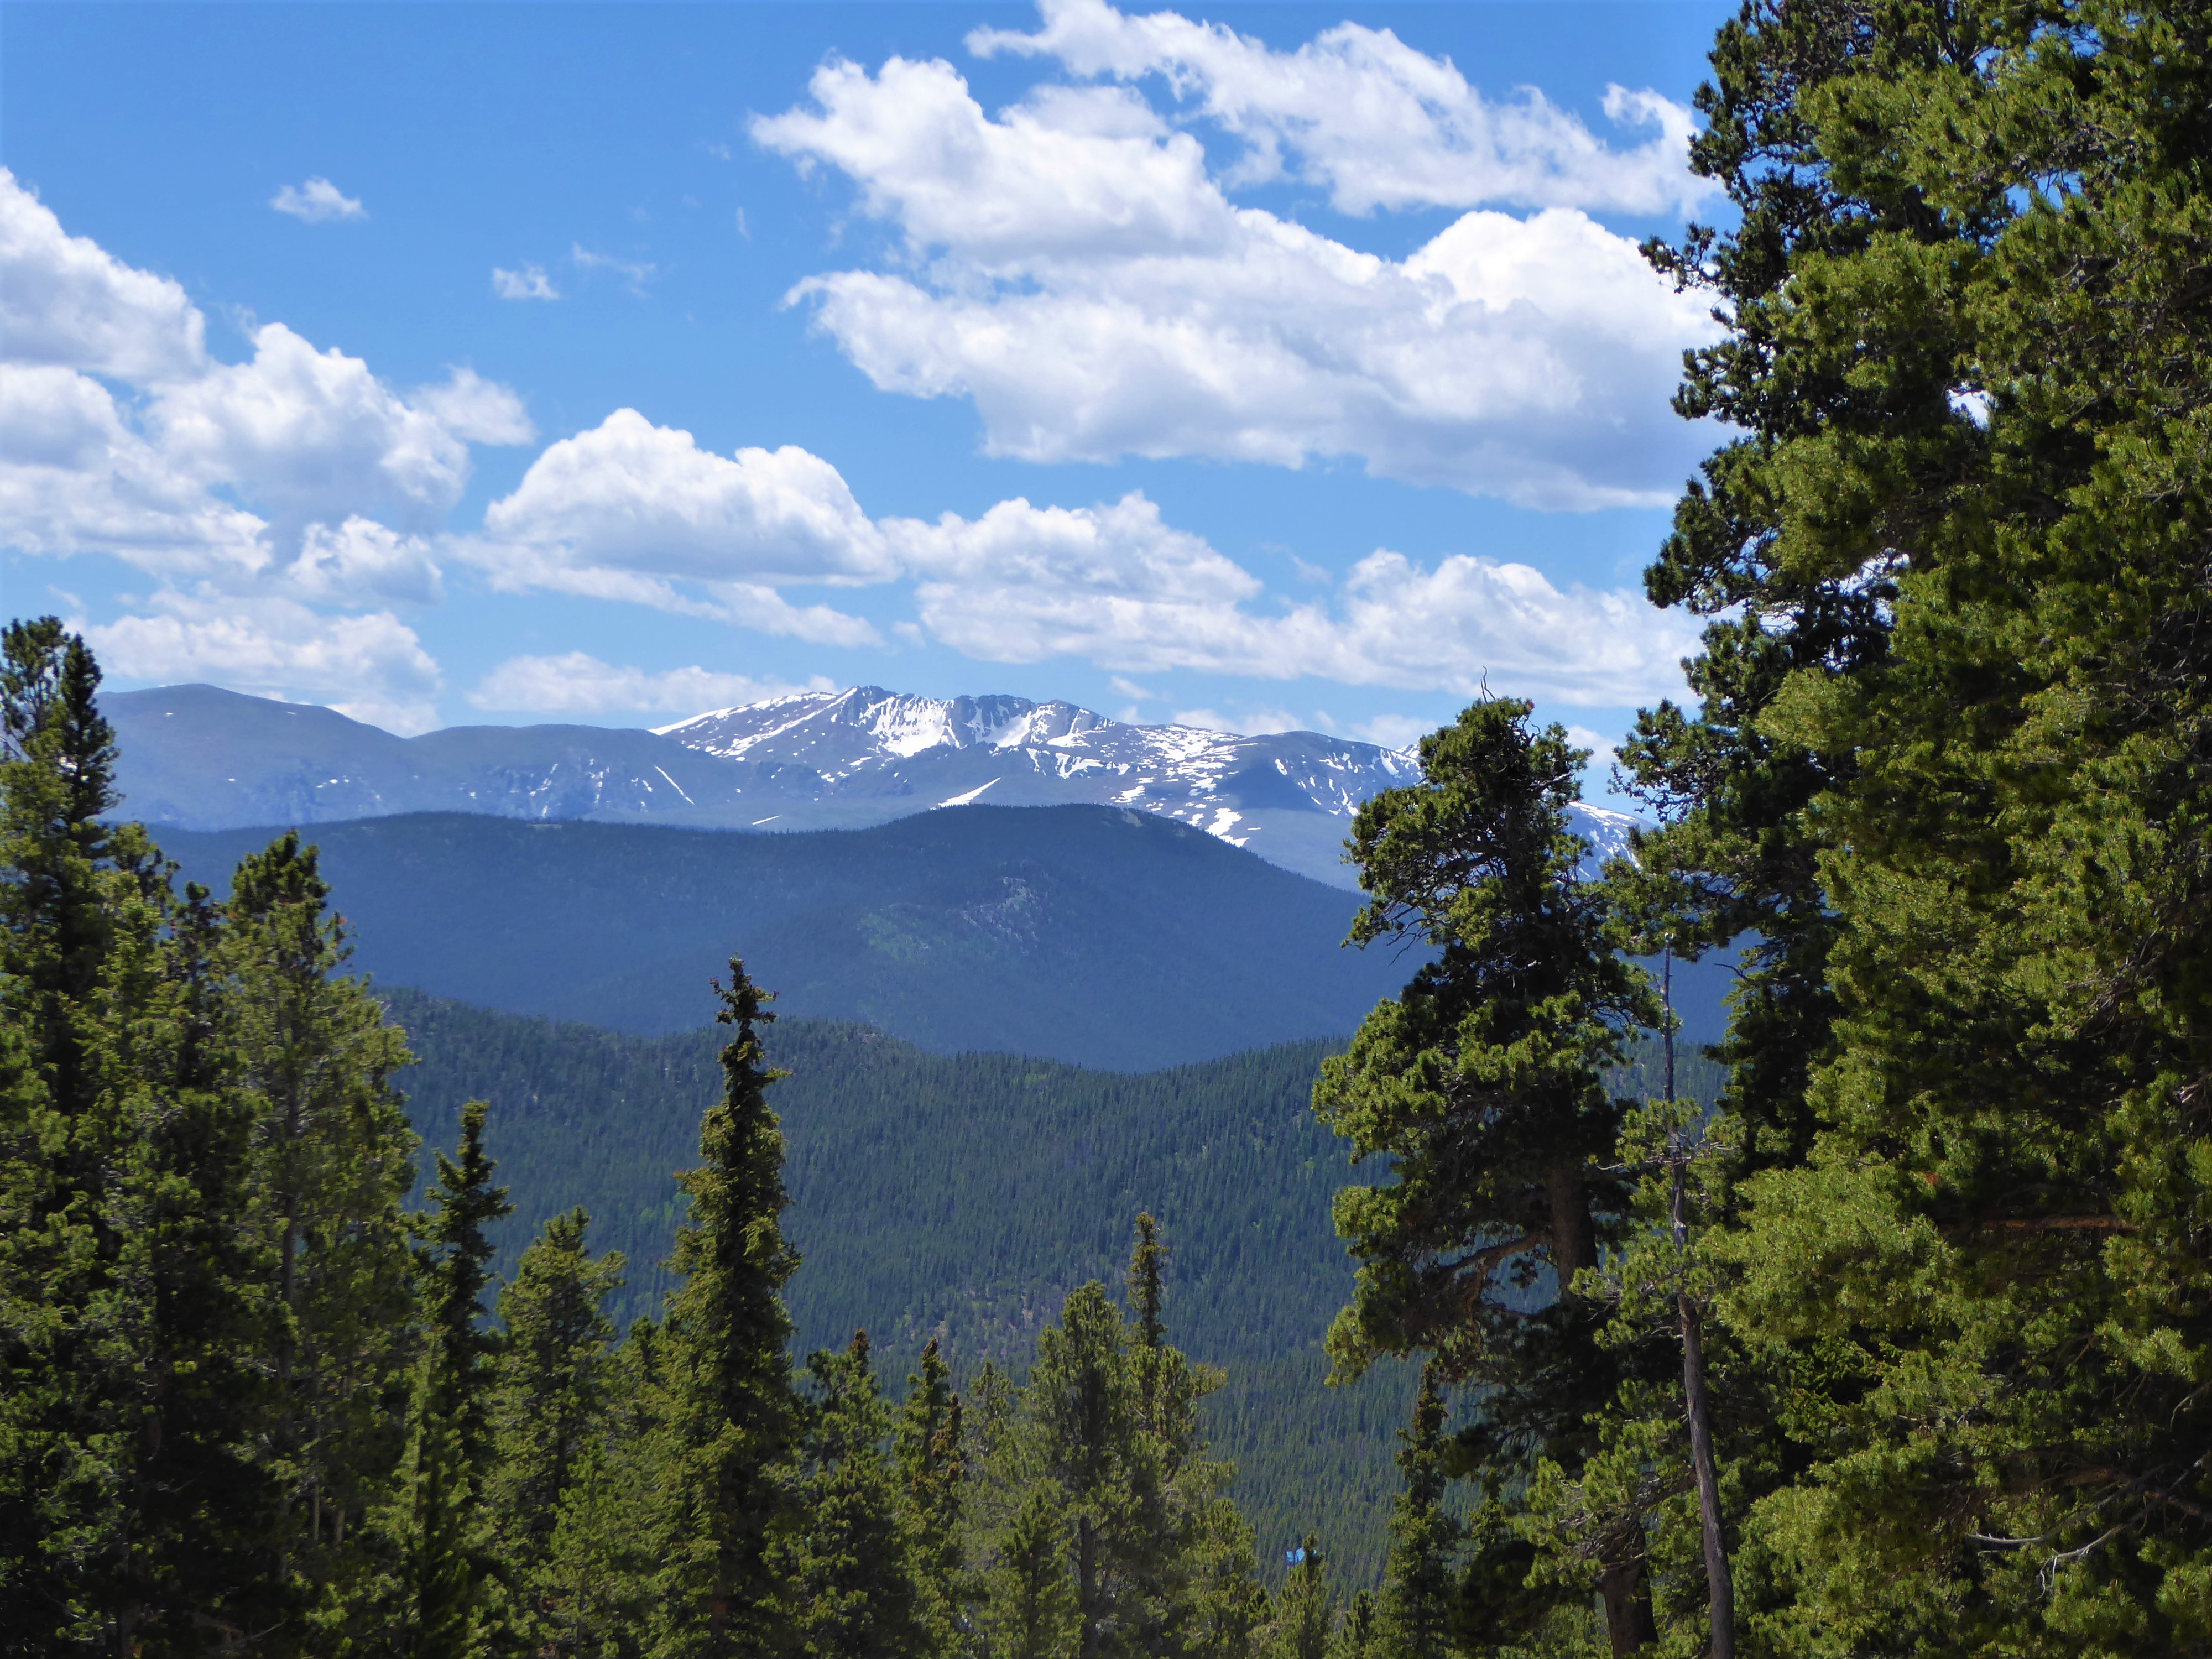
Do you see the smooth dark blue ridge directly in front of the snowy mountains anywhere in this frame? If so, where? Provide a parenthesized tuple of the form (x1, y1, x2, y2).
(164, 807, 1405, 1068)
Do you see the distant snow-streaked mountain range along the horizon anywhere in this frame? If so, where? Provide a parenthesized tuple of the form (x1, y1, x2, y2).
(104, 686, 1630, 885)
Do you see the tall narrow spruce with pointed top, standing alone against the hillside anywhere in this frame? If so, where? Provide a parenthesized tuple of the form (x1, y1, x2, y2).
(650, 958, 799, 1659)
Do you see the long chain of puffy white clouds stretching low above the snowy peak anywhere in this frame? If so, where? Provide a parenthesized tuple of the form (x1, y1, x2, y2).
(467, 409, 1694, 703)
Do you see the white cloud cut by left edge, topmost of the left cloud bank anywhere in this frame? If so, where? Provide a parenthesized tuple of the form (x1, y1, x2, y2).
(0, 168, 208, 383)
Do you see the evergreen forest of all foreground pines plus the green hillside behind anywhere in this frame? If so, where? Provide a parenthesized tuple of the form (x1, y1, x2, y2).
(0, 0, 2212, 1659)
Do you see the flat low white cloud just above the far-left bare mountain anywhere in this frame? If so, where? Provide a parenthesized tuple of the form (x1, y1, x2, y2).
(84, 593, 440, 732)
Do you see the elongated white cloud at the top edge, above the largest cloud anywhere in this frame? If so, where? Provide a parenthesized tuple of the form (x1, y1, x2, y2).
(969, 0, 1712, 212)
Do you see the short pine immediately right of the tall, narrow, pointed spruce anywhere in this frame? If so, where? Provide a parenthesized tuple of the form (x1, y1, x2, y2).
(781, 1332, 929, 1659)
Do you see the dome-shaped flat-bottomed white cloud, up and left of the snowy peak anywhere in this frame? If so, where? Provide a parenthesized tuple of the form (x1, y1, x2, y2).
(484, 409, 896, 586)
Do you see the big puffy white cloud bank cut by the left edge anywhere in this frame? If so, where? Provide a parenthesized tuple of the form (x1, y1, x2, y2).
(0, 170, 533, 591)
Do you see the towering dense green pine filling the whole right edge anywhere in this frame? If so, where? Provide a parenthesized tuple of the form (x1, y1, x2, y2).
(1619, 4, 2212, 1655)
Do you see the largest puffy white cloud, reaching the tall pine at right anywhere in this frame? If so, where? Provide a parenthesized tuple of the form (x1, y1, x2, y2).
(752, 58, 1714, 509)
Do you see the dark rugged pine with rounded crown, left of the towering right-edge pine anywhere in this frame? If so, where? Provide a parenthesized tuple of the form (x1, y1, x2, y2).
(1314, 699, 1659, 1655)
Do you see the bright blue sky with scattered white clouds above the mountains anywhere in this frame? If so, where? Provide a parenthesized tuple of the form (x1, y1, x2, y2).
(0, 0, 1725, 779)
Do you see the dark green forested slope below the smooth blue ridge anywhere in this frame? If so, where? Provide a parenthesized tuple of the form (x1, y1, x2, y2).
(378, 989, 1719, 1582)
